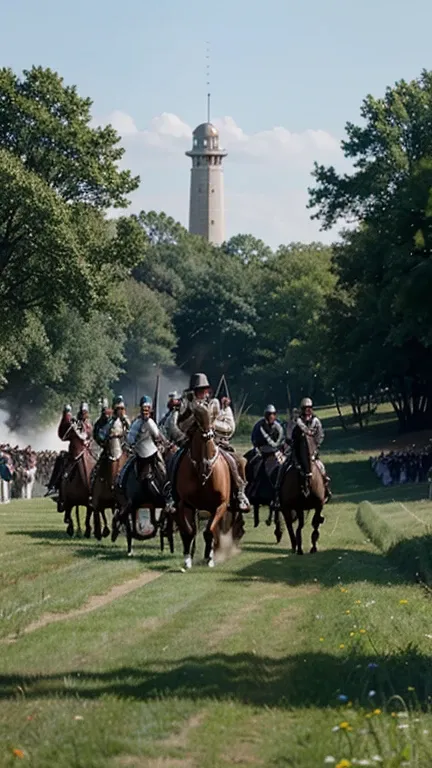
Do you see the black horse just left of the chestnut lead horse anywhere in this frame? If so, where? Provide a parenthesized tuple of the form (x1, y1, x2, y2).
(111, 456, 174, 557)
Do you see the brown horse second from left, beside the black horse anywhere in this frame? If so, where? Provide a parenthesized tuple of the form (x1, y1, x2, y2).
(88, 435, 129, 541)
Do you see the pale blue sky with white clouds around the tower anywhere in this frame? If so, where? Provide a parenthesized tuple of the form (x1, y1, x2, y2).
(0, 0, 432, 247)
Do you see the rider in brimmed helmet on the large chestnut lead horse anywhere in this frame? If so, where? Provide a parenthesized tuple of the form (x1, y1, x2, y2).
(178, 373, 250, 512)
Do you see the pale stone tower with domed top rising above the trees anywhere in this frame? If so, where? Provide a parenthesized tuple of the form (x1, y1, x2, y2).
(186, 122, 227, 245)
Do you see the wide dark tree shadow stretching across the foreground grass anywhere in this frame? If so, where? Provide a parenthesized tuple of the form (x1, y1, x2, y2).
(0, 638, 432, 708)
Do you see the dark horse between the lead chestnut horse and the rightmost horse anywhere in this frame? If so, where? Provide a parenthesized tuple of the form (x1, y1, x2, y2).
(244, 448, 283, 528)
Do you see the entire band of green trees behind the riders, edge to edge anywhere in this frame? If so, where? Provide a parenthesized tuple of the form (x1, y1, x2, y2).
(0, 67, 432, 429)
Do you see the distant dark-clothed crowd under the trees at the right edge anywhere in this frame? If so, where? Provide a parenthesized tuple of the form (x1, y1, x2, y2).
(370, 442, 432, 486)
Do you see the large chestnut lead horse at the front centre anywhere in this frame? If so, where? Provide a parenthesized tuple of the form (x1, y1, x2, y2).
(176, 405, 243, 569)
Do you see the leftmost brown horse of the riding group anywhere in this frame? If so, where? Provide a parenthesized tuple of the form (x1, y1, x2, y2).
(59, 413, 96, 536)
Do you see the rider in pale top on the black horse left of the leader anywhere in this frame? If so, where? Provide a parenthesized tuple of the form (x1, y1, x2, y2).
(127, 395, 175, 513)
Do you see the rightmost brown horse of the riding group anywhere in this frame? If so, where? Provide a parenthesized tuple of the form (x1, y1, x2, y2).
(275, 426, 325, 555)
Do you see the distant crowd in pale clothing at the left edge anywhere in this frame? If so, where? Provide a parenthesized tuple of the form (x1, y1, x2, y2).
(0, 443, 57, 504)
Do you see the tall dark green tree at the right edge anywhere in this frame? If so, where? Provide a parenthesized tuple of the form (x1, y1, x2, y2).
(310, 71, 432, 429)
